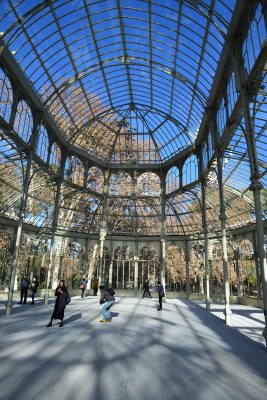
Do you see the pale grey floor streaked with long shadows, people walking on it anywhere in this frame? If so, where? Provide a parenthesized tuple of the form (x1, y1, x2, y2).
(0, 297, 267, 400)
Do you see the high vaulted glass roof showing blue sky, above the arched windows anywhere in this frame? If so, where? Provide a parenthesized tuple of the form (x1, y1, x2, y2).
(0, 0, 235, 164)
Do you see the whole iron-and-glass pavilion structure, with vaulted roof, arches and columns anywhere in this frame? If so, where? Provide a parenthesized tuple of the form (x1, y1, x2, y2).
(0, 0, 267, 337)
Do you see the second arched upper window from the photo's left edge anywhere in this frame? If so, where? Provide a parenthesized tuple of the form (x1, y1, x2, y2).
(14, 100, 33, 143)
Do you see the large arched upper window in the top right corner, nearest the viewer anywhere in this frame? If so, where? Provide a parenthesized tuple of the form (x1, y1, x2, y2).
(242, 2, 267, 73)
